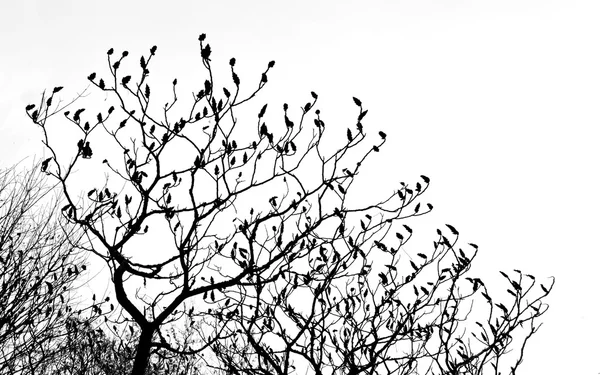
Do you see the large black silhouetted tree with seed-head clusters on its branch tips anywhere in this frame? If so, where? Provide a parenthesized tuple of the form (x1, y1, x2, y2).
(26, 34, 552, 375)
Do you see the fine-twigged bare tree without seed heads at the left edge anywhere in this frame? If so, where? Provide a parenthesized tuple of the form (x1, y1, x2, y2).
(0, 163, 85, 374)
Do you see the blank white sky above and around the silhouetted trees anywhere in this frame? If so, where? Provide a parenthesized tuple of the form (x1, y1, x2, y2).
(0, 0, 600, 375)
